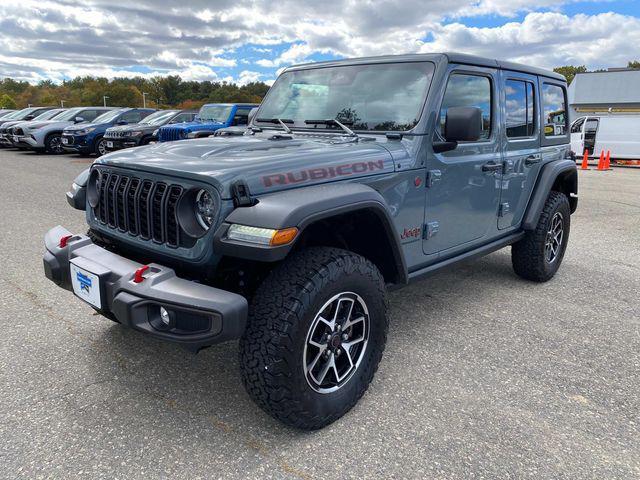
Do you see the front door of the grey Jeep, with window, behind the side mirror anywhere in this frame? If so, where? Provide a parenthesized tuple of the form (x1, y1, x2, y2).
(423, 66, 502, 257)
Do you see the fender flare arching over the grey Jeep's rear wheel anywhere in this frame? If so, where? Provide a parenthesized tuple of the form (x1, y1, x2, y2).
(522, 159, 578, 230)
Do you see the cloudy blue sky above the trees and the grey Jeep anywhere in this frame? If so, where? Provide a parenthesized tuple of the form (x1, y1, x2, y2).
(0, 0, 640, 83)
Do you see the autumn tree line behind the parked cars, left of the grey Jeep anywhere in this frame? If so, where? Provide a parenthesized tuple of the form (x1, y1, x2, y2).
(0, 75, 269, 108)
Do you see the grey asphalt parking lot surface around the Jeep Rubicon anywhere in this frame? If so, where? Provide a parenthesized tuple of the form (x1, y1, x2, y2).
(0, 150, 640, 479)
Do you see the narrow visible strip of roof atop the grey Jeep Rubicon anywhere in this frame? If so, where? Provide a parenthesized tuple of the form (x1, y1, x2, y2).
(286, 52, 566, 82)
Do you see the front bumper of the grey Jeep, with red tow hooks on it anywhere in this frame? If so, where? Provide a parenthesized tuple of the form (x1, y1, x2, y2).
(43, 226, 248, 351)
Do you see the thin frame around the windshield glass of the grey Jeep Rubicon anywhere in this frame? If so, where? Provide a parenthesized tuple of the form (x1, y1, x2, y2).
(251, 59, 437, 135)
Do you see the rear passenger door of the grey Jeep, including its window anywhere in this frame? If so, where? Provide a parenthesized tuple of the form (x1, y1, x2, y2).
(498, 71, 542, 230)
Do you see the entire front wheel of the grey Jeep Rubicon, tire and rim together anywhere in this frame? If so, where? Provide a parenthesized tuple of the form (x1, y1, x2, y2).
(240, 247, 388, 430)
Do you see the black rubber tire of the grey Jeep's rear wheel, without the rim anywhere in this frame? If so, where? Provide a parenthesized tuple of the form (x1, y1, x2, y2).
(511, 191, 571, 282)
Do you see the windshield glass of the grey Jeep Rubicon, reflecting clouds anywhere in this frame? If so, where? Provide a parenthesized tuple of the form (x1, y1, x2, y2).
(257, 62, 434, 131)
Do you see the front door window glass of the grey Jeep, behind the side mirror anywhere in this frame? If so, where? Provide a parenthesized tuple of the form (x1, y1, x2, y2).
(440, 73, 493, 140)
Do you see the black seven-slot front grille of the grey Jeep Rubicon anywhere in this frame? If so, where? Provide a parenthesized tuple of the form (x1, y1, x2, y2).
(94, 171, 189, 247)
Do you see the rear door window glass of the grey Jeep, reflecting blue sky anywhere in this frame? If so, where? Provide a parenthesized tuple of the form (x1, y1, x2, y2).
(505, 80, 536, 138)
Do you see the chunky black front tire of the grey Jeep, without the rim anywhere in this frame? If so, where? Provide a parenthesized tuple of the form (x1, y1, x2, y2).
(240, 247, 388, 430)
